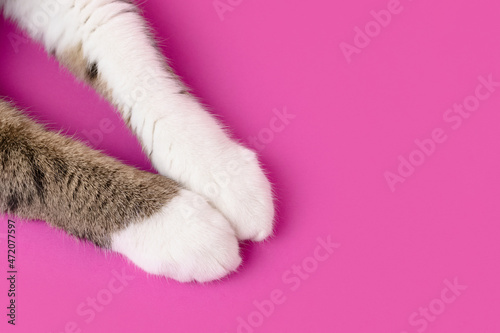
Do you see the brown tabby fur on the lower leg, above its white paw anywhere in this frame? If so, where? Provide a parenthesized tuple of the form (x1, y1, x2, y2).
(0, 99, 179, 247)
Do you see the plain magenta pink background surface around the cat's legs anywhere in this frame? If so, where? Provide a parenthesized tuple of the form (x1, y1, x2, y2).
(0, 0, 500, 333)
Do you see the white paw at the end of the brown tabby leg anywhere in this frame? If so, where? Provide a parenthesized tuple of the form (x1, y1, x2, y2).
(111, 189, 241, 282)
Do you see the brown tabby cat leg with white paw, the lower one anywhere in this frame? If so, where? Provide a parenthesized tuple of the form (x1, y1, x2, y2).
(0, 100, 241, 282)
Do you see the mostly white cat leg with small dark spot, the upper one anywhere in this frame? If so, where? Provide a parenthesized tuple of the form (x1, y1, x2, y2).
(0, 0, 274, 240)
